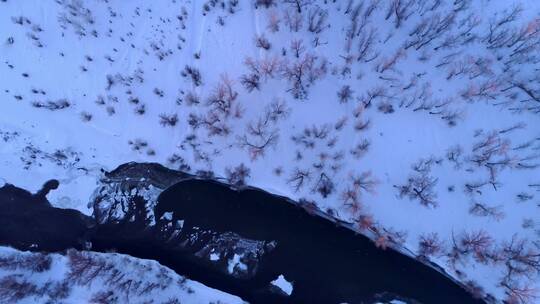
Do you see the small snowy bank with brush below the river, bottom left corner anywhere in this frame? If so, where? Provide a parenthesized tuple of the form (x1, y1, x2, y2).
(0, 247, 245, 304)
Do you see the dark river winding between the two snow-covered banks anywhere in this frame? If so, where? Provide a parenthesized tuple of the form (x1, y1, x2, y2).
(0, 180, 484, 304)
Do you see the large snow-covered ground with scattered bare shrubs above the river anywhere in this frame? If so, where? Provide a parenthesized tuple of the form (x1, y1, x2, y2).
(0, 0, 540, 303)
